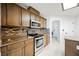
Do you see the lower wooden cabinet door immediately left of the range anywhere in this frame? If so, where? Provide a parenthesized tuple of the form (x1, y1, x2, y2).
(25, 39, 33, 56)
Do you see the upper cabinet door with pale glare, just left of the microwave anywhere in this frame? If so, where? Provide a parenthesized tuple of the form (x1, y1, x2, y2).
(22, 9, 30, 27)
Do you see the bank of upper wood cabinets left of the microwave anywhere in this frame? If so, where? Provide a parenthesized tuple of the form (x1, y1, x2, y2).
(1, 3, 30, 27)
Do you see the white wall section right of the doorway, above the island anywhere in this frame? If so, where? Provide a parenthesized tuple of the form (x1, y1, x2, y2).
(61, 16, 75, 37)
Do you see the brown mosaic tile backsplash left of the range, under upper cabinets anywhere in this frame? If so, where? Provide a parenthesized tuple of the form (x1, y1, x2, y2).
(1, 28, 27, 43)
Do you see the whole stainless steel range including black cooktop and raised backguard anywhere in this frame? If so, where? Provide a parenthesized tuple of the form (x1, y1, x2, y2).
(28, 30, 44, 55)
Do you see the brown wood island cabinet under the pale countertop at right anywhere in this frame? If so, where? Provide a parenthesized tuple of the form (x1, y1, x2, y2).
(65, 39, 79, 56)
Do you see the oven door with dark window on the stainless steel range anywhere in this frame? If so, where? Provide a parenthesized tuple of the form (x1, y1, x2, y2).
(35, 37, 44, 52)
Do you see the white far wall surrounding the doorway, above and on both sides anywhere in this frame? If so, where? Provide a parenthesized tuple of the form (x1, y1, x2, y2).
(47, 16, 76, 36)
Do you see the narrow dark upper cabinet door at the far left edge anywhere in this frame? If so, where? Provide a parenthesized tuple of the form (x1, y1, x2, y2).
(1, 3, 7, 26)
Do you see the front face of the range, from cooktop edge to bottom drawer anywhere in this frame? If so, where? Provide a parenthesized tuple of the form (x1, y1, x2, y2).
(34, 35, 44, 55)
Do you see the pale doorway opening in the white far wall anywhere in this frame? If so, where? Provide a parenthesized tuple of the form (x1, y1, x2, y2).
(52, 20, 60, 42)
